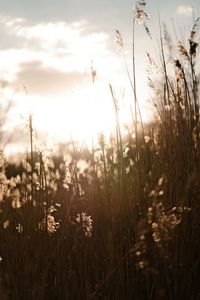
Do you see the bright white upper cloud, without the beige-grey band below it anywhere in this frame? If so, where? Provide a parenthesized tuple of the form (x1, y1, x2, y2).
(0, 16, 119, 80)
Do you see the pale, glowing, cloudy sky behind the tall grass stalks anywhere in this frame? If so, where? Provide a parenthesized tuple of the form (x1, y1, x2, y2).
(0, 0, 200, 154)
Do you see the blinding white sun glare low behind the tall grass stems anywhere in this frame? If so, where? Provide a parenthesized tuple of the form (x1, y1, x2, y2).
(3, 66, 150, 155)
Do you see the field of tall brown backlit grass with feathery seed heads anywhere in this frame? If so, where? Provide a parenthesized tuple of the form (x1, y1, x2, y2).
(0, 4, 200, 300)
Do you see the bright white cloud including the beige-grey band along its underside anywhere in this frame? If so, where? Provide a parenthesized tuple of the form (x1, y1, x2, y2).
(0, 15, 120, 95)
